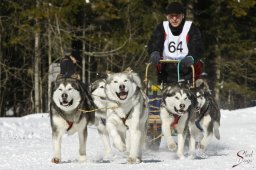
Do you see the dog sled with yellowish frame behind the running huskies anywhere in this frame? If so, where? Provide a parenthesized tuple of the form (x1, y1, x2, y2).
(144, 60, 196, 150)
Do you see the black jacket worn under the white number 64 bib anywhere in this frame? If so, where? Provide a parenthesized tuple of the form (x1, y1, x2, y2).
(148, 20, 204, 83)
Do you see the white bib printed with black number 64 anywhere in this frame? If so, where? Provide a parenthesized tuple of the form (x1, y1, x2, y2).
(163, 21, 192, 60)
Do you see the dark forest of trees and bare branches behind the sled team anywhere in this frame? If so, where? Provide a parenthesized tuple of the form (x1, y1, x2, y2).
(0, 0, 256, 117)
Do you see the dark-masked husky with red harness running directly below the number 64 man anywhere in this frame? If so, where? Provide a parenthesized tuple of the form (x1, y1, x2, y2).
(160, 84, 196, 159)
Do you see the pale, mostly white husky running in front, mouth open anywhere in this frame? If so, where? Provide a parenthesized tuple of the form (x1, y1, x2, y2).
(105, 68, 148, 164)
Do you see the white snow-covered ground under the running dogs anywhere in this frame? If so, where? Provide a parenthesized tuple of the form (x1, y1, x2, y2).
(0, 107, 256, 170)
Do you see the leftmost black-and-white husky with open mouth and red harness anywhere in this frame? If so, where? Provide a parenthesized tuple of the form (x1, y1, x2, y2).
(50, 78, 94, 163)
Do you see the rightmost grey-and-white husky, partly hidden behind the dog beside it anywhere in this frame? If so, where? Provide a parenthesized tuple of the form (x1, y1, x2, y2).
(189, 79, 221, 158)
